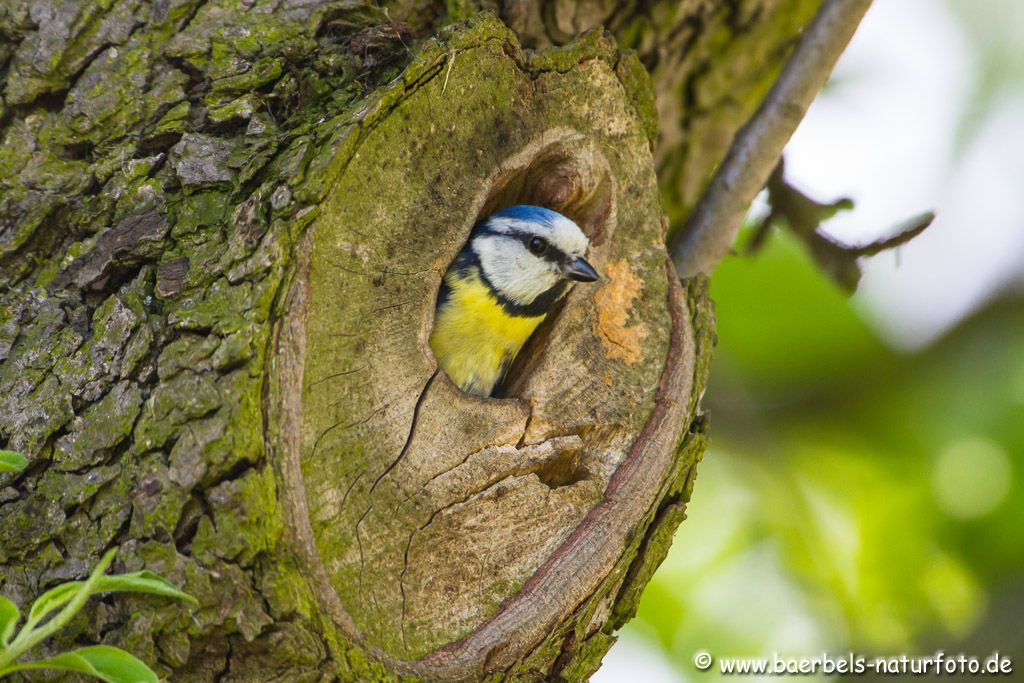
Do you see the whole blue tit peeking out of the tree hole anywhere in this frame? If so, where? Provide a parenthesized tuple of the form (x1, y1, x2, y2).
(430, 206, 598, 396)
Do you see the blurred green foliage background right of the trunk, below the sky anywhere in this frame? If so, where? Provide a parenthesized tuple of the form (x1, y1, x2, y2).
(627, 227, 1024, 680)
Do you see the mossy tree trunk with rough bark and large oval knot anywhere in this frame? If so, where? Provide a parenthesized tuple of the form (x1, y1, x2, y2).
(0, 0, 815, 681)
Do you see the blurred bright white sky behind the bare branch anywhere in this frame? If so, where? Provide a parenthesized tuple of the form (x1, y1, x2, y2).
(786, 0, 1024, 348)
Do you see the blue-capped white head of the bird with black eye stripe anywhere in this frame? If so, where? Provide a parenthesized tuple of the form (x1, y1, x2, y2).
(470, 205, 599, 305)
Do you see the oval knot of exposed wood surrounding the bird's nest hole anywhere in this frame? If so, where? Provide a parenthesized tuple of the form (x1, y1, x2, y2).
(272, 33, 698, 680)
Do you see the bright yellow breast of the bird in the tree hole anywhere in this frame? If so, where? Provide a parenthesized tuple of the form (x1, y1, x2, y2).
(430, 269, 545, 396)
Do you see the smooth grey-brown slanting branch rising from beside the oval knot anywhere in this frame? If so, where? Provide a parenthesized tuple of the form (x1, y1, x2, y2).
(669, 0, 871, 278)
